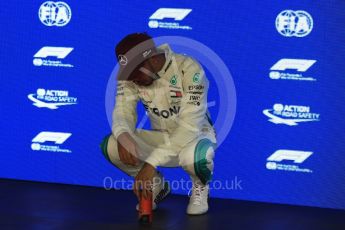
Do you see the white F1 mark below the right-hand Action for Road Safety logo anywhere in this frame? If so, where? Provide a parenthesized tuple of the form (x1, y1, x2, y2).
(267, 149, 313, 164)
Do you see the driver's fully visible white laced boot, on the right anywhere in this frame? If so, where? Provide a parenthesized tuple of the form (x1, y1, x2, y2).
(187, 179, 209, 215)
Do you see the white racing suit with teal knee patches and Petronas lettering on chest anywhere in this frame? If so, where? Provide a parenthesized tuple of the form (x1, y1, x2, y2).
(101, 44, 216, 184)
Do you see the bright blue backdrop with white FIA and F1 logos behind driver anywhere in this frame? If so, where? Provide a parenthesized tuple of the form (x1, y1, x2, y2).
(0, 0, 345, 209)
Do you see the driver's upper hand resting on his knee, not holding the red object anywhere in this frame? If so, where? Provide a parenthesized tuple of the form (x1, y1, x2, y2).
(117, 133, 139, 166)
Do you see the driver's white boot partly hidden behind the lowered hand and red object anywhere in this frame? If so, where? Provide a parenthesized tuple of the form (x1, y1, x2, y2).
(136, 172, 170, 211)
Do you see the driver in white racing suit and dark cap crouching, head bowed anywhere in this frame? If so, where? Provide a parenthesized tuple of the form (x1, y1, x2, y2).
(101, 33, 216, 215)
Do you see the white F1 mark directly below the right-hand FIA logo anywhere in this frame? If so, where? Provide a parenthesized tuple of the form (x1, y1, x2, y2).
(271, 58, 316, 72)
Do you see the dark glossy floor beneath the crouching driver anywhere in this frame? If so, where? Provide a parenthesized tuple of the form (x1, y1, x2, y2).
(0, 180, 345, 230)
